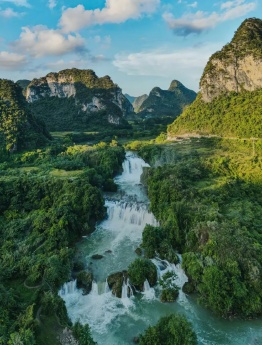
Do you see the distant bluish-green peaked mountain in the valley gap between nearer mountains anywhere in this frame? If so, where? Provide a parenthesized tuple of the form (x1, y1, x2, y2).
(139, 80, 196, 118)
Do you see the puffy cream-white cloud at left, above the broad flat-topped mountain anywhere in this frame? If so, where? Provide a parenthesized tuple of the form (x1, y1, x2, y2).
(13, 25, 85, 57)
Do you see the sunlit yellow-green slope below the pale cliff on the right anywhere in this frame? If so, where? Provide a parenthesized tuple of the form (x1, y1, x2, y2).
(168, 90, 262, 138)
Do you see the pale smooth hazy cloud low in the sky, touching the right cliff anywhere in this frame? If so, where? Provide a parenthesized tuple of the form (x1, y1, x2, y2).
(113, 43, 222, 90)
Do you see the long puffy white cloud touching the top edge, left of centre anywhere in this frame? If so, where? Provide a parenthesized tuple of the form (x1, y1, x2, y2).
(60, 0, 160, 32)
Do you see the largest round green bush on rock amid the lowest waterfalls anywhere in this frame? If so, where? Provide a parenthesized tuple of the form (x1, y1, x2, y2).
(128, 258, 157, 291)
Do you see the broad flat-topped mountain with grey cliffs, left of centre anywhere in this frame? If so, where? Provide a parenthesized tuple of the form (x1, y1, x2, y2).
(26, 68, 133, 130)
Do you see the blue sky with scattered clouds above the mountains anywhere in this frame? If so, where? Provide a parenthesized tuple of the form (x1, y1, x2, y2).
(0, 0, 262, 96)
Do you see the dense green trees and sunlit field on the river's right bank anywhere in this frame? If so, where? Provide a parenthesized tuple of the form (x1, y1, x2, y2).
(139, 138, 262, 317)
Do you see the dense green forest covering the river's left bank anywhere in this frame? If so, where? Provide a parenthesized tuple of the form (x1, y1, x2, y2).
(0, 141, 125, 345)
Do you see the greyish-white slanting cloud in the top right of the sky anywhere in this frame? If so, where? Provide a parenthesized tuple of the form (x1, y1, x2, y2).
(163, 0, 256, 36)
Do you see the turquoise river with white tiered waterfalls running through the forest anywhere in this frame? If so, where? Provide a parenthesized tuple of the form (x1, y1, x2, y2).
(59, 152, 262, 345)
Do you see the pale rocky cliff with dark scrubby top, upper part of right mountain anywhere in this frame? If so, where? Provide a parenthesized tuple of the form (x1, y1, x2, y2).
(200, 18, 262, 102)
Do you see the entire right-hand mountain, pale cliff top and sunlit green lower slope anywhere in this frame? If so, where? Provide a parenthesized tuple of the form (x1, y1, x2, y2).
(168, 18, 262, 138)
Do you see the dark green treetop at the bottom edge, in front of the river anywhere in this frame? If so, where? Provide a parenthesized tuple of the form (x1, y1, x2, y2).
(139, 315, 197, 345)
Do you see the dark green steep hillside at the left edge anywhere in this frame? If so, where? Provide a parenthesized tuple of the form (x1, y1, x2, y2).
(0, 79, 50, 152)
